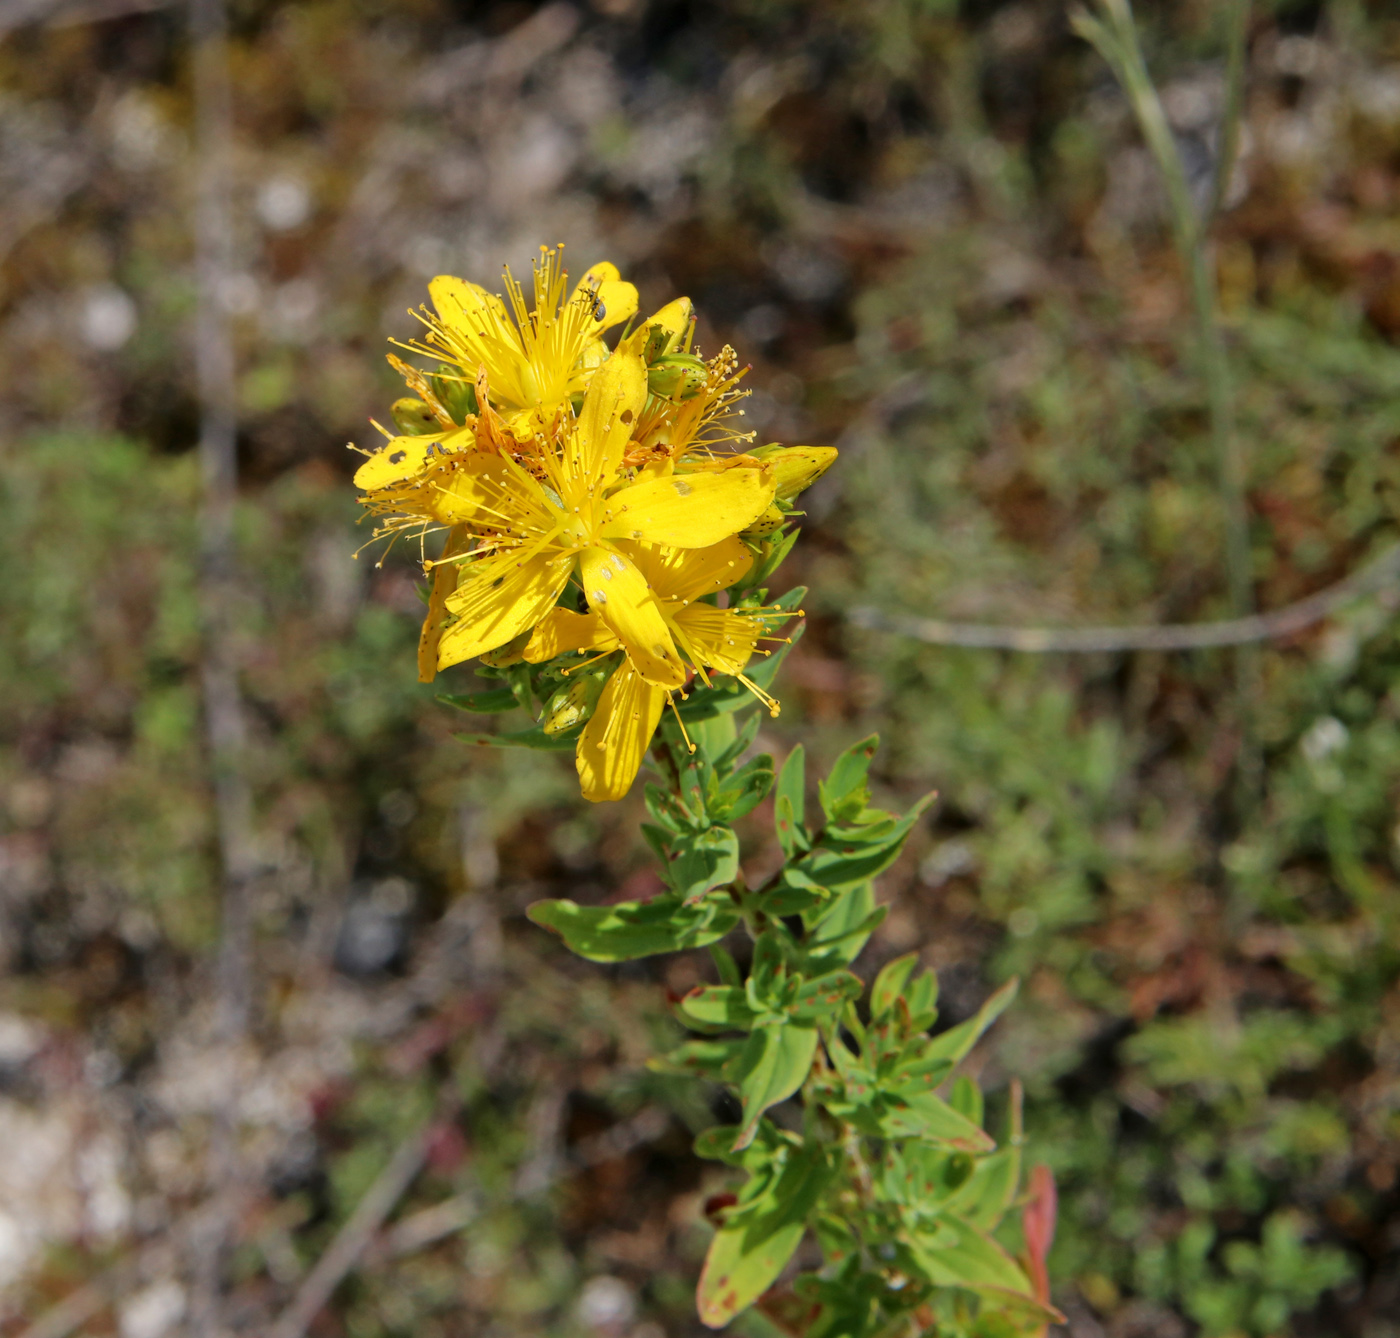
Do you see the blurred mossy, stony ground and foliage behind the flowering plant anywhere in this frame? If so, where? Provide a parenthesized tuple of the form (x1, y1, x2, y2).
(0, 0, 1400, 1338)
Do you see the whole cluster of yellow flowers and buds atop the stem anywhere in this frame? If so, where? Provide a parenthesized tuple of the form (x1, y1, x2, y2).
(356, 249, 836, 801)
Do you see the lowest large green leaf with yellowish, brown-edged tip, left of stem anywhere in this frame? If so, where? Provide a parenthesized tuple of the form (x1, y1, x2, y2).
(696, 1145, 832, 1328)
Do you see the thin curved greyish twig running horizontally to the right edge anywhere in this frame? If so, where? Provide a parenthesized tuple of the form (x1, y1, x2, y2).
(848, 547, 1400, 655)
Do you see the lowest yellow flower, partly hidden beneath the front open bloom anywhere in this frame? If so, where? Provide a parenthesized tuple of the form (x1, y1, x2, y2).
(525, 537, 791, 803)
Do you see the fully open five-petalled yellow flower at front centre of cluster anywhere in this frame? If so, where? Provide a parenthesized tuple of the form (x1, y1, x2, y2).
(433, 350, 774, 687)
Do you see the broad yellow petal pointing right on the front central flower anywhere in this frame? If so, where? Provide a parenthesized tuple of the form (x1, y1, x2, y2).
(599, 469, 773, 549)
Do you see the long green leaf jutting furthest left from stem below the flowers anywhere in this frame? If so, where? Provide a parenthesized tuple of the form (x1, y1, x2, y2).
(525, 897, 739, 962)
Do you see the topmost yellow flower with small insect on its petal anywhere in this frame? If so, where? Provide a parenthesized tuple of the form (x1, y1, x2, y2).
(409, 246, 637, 428)
